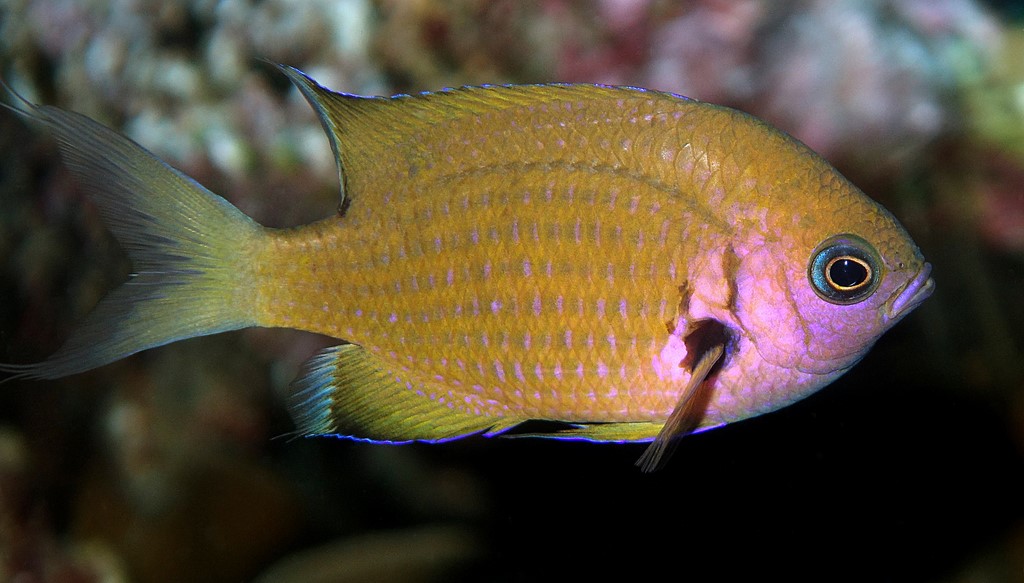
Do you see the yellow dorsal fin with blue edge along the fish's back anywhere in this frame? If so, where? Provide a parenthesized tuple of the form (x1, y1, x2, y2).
(279, 66, 715, 210)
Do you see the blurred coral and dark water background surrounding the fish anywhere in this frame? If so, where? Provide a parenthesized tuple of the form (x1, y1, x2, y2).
(0, 0, 1024, 583)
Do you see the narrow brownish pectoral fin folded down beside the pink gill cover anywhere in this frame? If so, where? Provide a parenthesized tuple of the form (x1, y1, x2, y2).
(636, 320, 729, 472)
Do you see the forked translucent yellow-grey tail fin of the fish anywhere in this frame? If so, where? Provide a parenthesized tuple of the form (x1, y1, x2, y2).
(0, 89, 262, 380)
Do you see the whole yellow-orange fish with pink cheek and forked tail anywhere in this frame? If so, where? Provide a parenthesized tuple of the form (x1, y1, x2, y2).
(0, 66, 935, 471)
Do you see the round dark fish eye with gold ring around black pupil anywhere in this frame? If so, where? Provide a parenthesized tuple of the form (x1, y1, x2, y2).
(807, 235, 882, 304)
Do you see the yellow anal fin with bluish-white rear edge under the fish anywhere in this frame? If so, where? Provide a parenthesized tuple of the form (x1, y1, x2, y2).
(291, 344, 512, 444)
